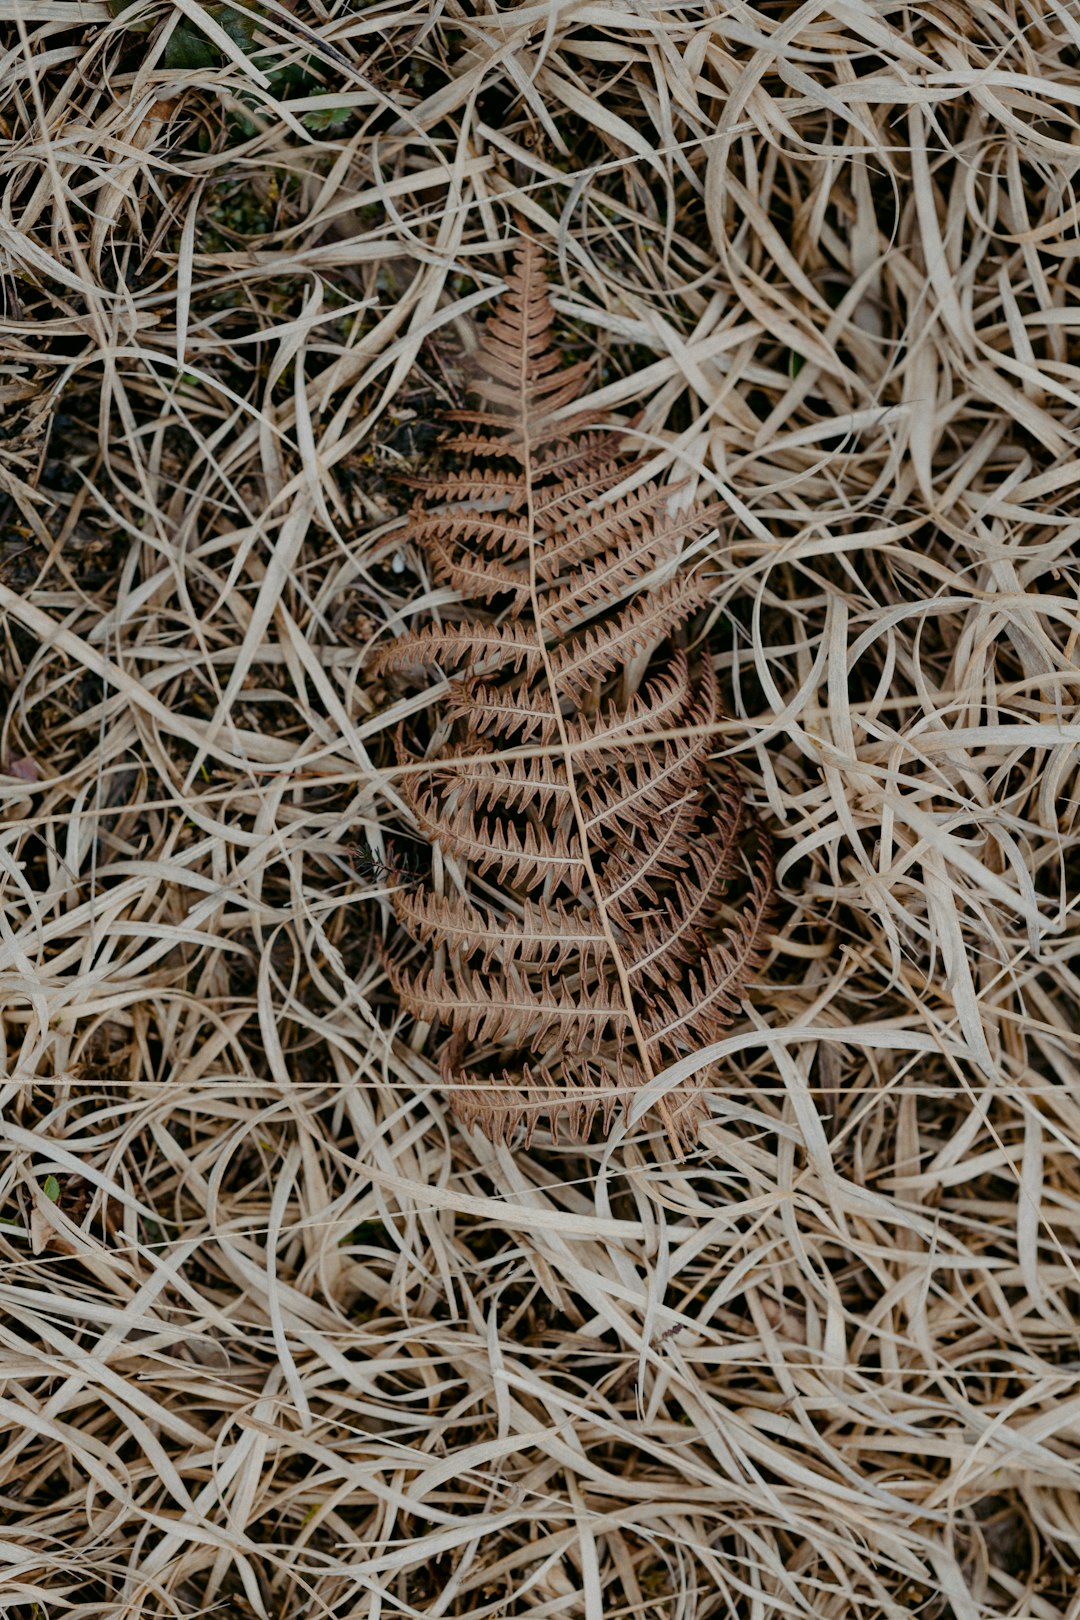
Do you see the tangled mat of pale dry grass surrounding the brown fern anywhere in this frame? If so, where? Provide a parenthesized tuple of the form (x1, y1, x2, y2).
(0, 0, 1080, 1620)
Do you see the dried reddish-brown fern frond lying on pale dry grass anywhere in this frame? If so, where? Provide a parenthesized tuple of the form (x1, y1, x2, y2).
(369, 238, 772, 1150)
